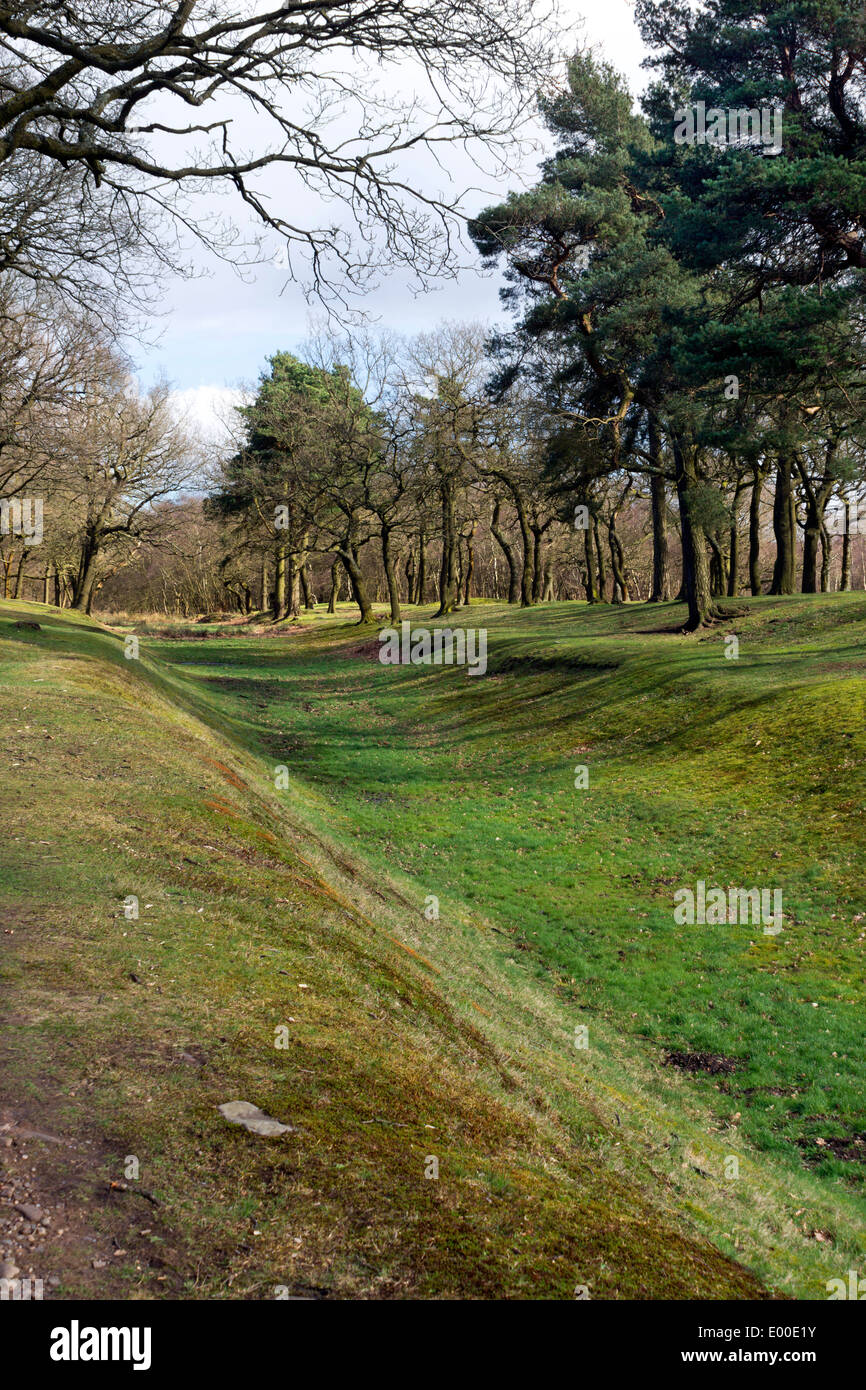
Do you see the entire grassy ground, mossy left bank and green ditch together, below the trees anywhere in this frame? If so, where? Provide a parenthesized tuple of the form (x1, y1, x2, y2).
(0, 595, 866, 1297)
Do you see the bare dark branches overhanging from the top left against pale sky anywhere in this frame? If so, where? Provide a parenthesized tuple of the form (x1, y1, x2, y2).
(0, 0, 550, 304)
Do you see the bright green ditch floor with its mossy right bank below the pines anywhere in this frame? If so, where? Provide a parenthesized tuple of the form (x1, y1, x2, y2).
(140, 595, 866, 1293)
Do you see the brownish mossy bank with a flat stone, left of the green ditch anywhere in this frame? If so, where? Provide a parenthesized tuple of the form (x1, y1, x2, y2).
(0, 605, 762, 1297)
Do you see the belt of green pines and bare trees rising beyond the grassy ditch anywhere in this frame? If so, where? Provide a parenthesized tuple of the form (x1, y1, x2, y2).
(0, 0, 866, 628)
